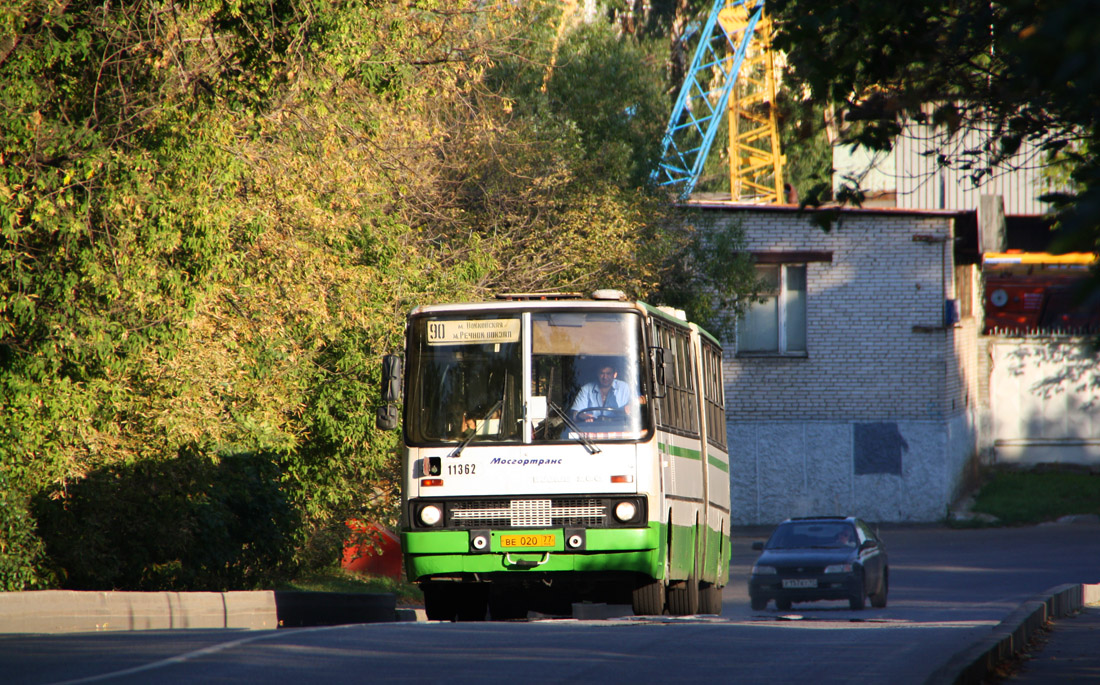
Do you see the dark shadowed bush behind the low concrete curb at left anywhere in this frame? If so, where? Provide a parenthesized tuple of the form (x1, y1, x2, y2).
(34, 451, 300, 590)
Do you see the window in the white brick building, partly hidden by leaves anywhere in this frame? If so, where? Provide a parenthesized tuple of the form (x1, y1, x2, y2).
(737, 264, 806, 354)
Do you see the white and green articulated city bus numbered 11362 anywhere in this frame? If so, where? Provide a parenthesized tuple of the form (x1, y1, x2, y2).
(378, 290, 729, 620)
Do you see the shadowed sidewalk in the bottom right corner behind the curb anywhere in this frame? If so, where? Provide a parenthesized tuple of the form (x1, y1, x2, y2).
(1009, 605, 1100, 685)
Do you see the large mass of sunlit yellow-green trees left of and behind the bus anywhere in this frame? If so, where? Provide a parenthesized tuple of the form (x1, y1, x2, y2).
(0, 0, 765, 589)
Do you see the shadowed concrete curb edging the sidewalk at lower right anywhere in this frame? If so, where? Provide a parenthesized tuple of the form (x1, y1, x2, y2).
(925, 584, 1100, 685)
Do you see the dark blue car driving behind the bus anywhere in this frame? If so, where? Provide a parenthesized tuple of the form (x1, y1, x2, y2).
(749, 517, 890, 611)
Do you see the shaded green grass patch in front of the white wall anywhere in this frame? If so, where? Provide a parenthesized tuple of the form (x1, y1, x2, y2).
(971, 471, 1100, 526)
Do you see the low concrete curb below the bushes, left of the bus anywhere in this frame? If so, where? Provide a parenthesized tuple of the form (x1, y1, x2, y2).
(0, 590, 398, 633)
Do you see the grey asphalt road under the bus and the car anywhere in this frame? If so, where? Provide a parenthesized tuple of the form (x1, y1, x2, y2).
(0, 524, 1100, 684)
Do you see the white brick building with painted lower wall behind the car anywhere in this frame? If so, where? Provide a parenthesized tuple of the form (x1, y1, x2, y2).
(691, 202, 978, 524)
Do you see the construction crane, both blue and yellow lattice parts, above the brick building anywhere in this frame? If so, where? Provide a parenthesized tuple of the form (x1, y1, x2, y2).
(653, 0, 785, 203)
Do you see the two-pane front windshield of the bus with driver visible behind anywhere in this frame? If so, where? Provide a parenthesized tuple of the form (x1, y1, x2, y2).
(405, 310, 651, 445)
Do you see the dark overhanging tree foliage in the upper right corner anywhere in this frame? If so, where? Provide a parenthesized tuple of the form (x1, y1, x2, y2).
(768, 0, 1100, 284)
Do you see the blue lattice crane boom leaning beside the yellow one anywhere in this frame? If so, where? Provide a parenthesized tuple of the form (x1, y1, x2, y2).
(652, 0, 763, 198)
